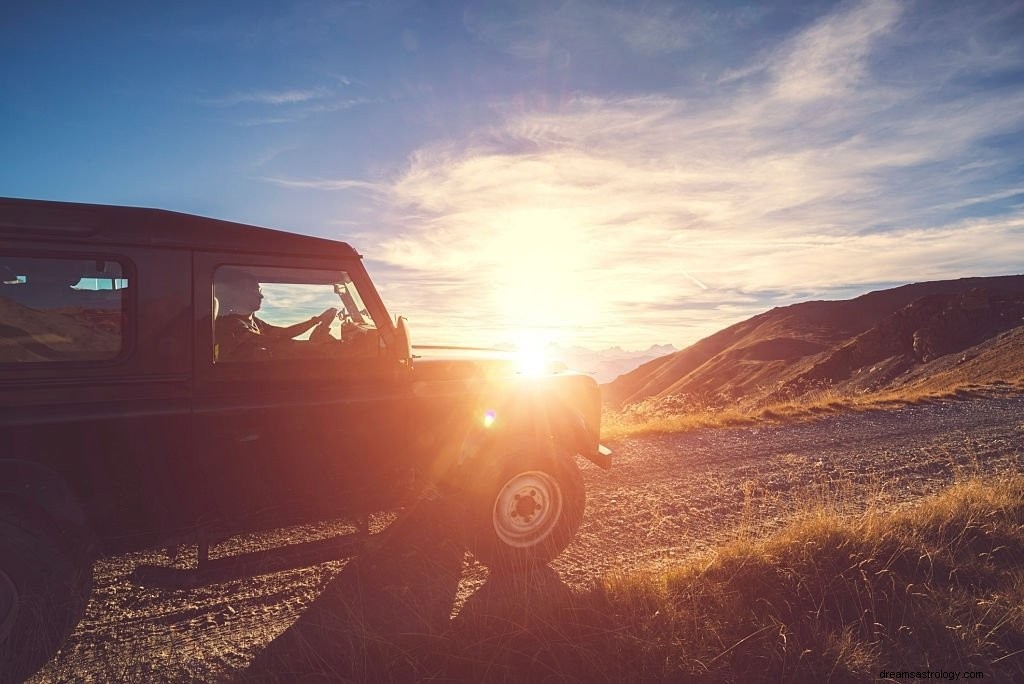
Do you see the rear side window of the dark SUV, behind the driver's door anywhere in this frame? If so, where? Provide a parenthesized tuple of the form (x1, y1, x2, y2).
(0, 255, 129, 364)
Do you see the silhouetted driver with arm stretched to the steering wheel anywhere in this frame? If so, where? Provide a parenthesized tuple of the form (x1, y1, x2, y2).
(214, 268, 338, 360)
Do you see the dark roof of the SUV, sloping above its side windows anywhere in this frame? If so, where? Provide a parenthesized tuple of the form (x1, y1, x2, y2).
(0, 198, 359, 258)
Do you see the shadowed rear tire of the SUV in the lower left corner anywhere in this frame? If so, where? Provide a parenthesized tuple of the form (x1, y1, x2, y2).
(0, 507, 92, 684)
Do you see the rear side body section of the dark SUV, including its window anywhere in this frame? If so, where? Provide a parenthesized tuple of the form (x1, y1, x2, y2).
(0, 243, 191, 549)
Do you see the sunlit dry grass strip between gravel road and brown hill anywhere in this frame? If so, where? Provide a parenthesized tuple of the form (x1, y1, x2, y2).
(601, 382, 1024, 441)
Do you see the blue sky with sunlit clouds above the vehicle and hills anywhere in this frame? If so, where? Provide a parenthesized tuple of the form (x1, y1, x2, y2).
(0, 0, 1024, 349)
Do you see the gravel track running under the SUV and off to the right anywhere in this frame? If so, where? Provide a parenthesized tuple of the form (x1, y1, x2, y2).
(31, 396, 1024, 682)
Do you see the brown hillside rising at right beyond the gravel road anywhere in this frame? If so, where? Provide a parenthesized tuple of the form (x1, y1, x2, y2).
(603, 275, 1024, 407)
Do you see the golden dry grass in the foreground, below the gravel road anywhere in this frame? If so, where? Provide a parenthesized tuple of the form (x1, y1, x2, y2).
(247, 474, 1024, 682)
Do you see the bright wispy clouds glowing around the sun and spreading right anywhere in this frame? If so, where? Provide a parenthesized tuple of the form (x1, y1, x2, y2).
(299, 0, 1024, 347)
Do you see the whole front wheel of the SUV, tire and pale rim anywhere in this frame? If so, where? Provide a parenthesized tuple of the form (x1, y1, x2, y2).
(464, 440, 586, 571)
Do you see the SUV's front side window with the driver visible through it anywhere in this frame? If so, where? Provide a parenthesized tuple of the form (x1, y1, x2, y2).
(212, 265, 380, 364)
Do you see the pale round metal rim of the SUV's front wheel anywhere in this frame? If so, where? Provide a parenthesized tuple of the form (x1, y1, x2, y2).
(493, 470, 562, 548)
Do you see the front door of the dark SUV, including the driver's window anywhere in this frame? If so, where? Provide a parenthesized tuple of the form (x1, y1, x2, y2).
(194, 253, 409, 529)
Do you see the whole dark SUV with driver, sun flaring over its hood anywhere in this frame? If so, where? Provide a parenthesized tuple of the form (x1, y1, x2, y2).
(0, 200, 610, 678)
